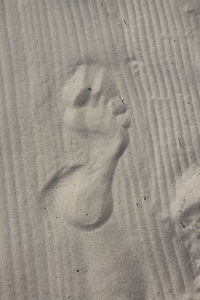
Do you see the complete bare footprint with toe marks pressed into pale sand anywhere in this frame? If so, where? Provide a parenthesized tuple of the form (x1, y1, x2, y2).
(42, 65, 130, 230)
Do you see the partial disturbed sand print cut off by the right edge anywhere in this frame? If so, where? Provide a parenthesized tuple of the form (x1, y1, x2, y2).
(171, 169, 200, 300)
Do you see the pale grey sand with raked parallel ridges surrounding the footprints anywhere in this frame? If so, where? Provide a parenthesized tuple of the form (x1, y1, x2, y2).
(0, 0, 200, 300)
